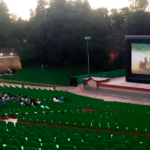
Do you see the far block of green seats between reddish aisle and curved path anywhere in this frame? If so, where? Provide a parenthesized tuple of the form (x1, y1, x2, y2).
(0, 86, 150, 133)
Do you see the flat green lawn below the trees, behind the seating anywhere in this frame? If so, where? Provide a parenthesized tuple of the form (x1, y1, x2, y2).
(0, 67, 87, 86)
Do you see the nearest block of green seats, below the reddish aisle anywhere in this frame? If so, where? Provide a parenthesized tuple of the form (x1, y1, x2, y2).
(0, 121, 150, 150)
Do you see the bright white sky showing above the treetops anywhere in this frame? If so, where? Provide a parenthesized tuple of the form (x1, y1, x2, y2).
(3, 0, 129, 20)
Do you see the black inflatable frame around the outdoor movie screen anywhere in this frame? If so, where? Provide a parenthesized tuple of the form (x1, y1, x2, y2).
(125, 35, 150, 83)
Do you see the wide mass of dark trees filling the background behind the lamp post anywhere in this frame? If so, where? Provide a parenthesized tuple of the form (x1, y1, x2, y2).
(0, 0, 150, 71)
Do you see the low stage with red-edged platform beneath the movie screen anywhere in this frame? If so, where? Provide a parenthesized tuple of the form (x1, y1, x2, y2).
(85, 77, 150, 101)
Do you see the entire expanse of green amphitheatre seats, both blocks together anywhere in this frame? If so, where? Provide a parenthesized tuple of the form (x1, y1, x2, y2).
(0, 85, 150, 150)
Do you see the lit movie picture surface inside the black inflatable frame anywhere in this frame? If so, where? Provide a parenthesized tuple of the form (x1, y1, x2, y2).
(131, 43, 150, 75)
